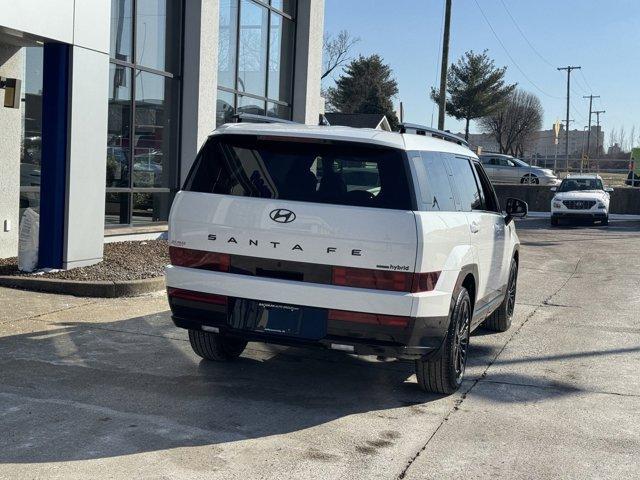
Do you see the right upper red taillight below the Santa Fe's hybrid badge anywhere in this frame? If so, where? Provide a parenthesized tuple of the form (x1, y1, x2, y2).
(331, 267, 440, 293)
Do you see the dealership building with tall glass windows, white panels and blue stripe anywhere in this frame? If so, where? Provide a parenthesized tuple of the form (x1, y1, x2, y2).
(0, 0, 324, 268)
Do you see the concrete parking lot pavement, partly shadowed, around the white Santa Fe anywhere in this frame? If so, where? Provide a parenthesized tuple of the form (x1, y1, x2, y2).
(0, 220, 640, 479)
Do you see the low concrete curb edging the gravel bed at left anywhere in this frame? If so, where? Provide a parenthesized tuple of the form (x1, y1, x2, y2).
(0, 275, 165, 298)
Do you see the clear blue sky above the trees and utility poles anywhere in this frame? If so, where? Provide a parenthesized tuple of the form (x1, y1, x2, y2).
(325, 0, 640, 143)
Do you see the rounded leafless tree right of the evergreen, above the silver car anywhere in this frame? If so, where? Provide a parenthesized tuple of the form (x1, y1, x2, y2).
(480, 90, 543, 156)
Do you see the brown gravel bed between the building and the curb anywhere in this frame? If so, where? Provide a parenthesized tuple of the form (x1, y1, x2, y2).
(0, 240, 169, 281)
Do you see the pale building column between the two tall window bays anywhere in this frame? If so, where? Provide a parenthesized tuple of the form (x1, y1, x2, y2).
(180, 0, 219, 185)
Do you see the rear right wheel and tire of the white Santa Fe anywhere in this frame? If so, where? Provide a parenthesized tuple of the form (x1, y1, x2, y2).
(416, 287, 473, 395)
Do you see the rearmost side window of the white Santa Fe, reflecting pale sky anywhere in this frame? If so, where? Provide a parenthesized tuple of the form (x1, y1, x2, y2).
(416, 152, 456, 212)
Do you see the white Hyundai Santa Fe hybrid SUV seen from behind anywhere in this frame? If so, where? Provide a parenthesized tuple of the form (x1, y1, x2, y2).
(166, 123, 527, 393)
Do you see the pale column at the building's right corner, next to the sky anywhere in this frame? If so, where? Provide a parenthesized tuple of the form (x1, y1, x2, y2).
(293, 0, 324, 125)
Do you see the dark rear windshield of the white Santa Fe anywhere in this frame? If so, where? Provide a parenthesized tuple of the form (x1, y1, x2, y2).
(184, 135, 412, 210)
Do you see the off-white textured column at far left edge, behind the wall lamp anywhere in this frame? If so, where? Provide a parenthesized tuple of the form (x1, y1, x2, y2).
(0, 44, 24, 258)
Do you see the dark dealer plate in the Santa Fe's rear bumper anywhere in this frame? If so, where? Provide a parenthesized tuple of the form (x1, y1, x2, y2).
(229, 299, 327, 339)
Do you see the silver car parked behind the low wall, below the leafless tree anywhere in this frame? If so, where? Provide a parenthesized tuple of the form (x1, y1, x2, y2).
(480, 153, 560, 186)
